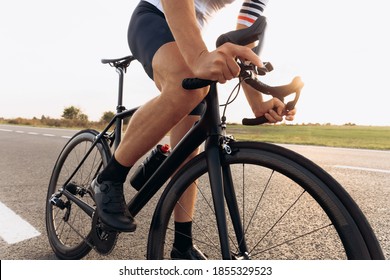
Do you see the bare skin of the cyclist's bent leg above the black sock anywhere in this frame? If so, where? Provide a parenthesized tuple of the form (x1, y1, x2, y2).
(115, 42, 208, 166)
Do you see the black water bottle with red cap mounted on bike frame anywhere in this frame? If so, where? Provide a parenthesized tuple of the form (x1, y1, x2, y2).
(130, 144, 171, 191)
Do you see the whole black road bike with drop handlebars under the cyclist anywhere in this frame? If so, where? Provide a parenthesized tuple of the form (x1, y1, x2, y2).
(46, 18, 384, 260)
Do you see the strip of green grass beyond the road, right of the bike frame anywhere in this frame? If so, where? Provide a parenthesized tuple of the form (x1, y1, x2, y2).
(227, 125, 390, 150)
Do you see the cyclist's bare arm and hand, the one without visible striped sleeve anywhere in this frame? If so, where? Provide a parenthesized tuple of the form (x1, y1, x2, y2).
(162, 0, 261, 83)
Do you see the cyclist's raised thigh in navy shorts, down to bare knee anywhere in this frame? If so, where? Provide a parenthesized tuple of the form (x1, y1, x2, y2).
(128, 1, 205, 115)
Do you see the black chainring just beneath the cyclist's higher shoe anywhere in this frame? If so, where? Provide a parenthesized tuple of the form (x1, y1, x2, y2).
(91, 211, 119, 255)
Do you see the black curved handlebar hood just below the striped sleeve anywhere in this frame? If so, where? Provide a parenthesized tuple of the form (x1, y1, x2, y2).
(216, 16, 267, 54)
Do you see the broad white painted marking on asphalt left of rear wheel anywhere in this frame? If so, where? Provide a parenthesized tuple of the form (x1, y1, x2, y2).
(0, 202, 41, 244)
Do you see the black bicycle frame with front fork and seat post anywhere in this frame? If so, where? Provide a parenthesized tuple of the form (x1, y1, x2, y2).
(63, 60, 246, 259)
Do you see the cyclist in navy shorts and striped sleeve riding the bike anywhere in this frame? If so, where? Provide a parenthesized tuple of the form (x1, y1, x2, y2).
(92, 0, 295, 259)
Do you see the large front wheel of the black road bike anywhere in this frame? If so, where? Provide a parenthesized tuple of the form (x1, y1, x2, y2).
(147, 142, 384, 259)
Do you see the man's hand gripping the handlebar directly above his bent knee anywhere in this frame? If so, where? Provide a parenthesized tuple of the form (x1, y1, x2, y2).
(194, 43, 263, 84)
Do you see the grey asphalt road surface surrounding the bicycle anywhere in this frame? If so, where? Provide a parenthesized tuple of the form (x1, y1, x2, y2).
(0, 125, 390, 260)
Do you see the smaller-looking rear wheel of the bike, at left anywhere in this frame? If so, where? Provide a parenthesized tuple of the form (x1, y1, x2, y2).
(46, 129, 111, 259)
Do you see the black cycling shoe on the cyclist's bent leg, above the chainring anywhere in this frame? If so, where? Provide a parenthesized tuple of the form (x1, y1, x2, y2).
(91, 179, 137, 232)
